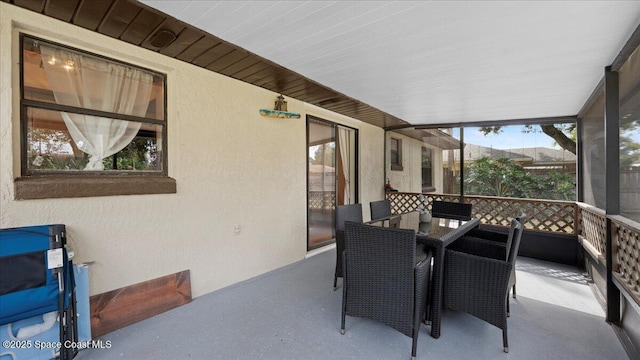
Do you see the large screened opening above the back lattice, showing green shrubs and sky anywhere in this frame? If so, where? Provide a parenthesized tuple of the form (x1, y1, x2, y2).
(457, 123, 576, 201)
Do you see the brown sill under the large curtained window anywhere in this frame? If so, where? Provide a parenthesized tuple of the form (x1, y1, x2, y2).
(14, 176, 176, 200)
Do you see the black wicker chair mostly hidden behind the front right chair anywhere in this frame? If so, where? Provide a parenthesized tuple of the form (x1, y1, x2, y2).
(456, 214, 527, 299)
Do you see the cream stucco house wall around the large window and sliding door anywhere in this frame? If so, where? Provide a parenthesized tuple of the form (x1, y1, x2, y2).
(0, 3, 384, 296)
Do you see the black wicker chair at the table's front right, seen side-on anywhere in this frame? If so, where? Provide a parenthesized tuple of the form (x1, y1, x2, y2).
(444, 219, 522, 352)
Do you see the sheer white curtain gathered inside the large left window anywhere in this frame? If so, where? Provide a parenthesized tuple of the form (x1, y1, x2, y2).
(40, 45, 153, 170)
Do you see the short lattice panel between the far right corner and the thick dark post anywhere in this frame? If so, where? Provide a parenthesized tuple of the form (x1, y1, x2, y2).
(578, 203, 607, 258)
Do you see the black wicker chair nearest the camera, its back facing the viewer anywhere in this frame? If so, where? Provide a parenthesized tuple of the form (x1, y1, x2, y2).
(340, 222, 431, 358)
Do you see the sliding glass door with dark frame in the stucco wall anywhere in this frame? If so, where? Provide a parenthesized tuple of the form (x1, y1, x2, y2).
(307, 117, 357, 250)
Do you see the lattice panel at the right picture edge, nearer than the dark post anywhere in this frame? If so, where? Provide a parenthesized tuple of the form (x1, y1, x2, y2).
(610, 216, 640, 304)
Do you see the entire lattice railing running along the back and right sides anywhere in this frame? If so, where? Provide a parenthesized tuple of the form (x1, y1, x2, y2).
(387, 192, 640, 305)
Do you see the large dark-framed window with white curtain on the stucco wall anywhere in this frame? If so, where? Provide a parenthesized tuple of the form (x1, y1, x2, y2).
(16, 35, 175, 198)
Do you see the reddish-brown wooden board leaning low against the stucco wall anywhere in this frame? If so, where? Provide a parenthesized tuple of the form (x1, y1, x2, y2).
(89, 270, 191, 338)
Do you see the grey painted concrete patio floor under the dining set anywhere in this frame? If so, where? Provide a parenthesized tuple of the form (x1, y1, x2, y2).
(77, 249, 628, 360)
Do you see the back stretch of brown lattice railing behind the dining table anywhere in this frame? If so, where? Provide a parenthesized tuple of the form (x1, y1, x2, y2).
(387, 192, 577, 234)
